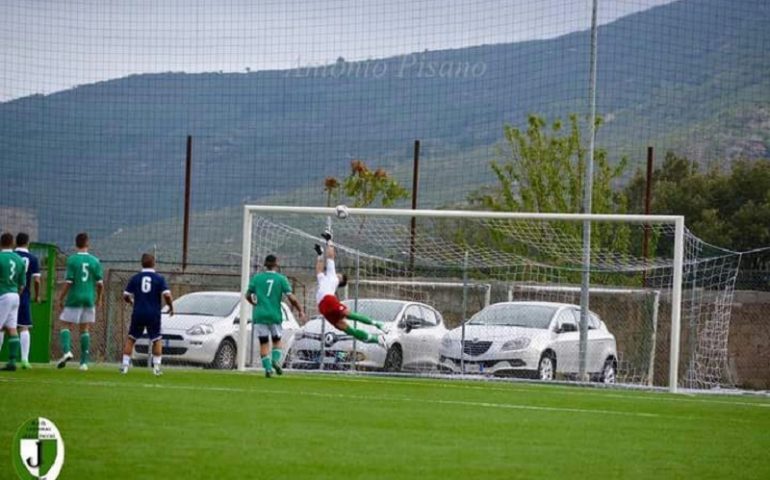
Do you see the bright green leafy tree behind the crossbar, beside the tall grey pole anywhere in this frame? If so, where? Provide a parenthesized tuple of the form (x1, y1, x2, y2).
(469, 114, 630, 258)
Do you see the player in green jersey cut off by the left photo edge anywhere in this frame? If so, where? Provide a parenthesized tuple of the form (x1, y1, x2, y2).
(0, 233, 27, 371)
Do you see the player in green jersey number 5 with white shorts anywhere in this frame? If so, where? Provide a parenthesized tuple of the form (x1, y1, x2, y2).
(56, 233, 104, 370)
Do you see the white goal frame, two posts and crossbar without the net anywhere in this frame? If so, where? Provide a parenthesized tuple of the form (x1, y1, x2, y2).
(238, 205, 685, 392)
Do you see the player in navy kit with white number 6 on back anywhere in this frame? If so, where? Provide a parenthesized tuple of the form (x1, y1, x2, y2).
(120, 253, 174, 375)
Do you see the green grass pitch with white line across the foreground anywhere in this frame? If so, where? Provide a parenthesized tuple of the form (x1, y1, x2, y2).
(0, 366, 770, 480)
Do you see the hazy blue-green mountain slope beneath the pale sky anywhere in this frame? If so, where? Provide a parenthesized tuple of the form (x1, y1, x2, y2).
(0, 0, 770, 258)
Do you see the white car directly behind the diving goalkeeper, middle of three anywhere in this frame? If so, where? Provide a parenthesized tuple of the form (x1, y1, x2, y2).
(287, 299, 447, 372)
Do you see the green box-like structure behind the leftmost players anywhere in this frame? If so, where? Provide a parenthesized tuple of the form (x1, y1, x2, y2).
(0, 243, 59, 363)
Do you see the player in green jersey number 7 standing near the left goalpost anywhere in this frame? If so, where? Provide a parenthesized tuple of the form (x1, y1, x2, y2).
(246, 255, 305, 378)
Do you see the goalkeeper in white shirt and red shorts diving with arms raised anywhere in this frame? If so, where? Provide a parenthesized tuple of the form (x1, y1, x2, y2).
(315, 232, 386, 347)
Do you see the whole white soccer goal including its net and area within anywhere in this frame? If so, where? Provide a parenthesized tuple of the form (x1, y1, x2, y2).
(238, 205, 737, 391)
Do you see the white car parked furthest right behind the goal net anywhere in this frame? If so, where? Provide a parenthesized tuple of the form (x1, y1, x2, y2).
(440, 302, 618, 383)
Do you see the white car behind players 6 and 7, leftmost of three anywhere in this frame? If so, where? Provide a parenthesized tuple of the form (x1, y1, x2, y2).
(134, 292, 299, 369)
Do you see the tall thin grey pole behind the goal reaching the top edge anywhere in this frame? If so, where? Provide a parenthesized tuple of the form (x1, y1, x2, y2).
(579, 0, 599, 381)
